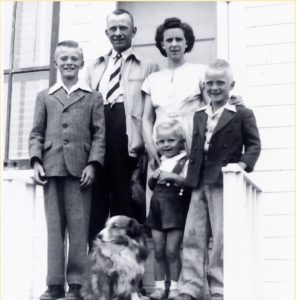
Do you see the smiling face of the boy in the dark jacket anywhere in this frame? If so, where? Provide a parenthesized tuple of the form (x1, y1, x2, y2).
(205, 69, 234, 104)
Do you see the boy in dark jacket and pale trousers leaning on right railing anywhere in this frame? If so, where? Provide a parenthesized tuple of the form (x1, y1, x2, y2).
(178, 59, 261, 300)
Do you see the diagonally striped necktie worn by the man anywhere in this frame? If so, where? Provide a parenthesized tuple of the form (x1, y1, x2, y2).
(106, 53, 122, 103)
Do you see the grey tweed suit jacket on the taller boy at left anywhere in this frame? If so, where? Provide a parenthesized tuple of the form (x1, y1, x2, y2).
(29, 88, 105, 177)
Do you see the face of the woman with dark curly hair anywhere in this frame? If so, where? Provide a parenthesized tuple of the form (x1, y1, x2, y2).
(162, 28, 187, 61)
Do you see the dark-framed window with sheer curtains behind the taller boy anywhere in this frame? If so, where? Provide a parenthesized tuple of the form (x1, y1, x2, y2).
(2, 1, 59, 168)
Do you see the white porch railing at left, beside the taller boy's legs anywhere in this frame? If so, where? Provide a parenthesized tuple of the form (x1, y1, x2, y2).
(1, 170, 46, 300)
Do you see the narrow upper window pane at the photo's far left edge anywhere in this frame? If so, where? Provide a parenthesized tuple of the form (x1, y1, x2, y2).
(1, 2, 13, 69)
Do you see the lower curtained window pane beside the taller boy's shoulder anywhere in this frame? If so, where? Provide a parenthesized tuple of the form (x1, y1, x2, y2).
(9, 71, 49, 159)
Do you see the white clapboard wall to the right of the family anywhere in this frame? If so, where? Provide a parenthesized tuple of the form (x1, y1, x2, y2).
(227, 1, 295, 300)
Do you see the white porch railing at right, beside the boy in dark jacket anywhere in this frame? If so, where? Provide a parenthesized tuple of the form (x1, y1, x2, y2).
(222, 164, 261, 300)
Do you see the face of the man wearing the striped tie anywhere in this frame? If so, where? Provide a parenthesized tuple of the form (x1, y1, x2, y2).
(105, 14, 137, 52)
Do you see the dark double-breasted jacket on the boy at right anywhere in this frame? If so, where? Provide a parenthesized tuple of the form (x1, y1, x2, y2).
(186, 106, 261, 188)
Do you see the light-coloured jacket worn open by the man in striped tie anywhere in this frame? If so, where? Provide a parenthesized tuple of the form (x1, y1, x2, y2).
(86, 50, 158, 157)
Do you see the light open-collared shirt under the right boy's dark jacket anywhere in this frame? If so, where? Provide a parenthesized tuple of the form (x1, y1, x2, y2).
(199, 102, 236, 152)
